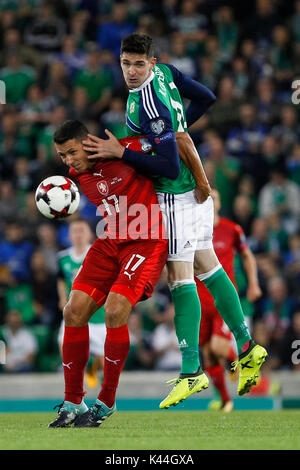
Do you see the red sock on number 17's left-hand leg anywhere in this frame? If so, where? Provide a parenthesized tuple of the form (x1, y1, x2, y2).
(62, 325, 89, 404)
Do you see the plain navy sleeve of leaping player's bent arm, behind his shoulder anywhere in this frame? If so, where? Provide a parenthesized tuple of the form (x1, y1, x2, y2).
(165, 64, 216, 127)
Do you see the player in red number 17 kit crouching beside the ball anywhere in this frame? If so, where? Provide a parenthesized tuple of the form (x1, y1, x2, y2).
(49, 121, 168, 427)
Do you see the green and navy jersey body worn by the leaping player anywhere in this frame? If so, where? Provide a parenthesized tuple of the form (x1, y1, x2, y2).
(126, 64, 196, 194)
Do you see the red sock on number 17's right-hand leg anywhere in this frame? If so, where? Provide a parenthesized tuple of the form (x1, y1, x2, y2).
(98, 325, 130, 408)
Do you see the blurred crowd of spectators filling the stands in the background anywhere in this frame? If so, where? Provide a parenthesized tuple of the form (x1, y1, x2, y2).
(0, 0, 300, 371)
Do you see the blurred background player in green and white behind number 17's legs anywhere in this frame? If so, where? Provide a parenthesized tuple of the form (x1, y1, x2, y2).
(57, 219, 106, 388)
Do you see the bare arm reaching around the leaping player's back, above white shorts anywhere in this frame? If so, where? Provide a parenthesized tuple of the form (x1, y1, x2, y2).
(175, 132, 211, 203)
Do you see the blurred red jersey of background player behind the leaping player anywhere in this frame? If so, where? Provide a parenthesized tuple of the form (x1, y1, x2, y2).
(197, 217, 248, 305)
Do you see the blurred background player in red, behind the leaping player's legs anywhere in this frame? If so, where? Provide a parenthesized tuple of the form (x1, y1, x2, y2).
(195, 189, 262, 412)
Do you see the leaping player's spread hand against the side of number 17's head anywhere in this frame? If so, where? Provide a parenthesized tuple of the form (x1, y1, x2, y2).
(82, 129, 125, 160)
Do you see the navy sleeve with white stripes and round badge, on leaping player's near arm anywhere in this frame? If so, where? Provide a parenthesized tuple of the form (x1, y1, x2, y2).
(123, 83, 180, 179)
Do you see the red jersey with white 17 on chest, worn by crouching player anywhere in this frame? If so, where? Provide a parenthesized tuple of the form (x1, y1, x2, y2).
(69, 137, 166, 241)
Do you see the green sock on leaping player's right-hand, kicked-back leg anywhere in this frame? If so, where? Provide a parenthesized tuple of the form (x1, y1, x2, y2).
(203, 268, 251, 354)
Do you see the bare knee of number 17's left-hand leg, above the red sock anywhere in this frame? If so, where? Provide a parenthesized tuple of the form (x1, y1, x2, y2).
(63, 290, 99, 326)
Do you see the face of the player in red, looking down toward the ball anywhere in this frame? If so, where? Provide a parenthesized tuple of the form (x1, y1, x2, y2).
(55, 139, 95, 173)
